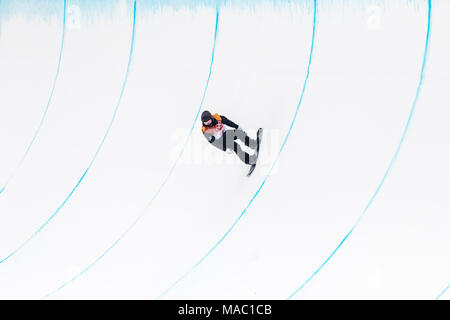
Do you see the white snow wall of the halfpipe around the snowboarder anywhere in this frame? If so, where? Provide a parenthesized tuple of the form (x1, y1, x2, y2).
(0, 0, 450, 299)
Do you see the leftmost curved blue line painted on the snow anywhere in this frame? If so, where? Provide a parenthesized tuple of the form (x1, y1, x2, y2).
(0, 0, 67, 195)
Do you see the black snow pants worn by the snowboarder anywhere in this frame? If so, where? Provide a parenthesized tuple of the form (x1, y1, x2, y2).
(213, 128, 258, 165)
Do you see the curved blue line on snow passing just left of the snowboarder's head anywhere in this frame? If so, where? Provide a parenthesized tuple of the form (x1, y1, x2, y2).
(43, 8, 219, 299)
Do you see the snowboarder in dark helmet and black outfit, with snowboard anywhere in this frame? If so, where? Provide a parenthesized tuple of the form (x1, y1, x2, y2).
(202, 111, 262, 175)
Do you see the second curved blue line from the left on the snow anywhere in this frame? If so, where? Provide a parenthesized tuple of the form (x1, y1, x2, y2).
(0, 0, 136, 263)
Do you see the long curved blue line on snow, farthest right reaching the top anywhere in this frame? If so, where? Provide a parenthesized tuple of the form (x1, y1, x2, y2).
(287, 0, 431, 300)
